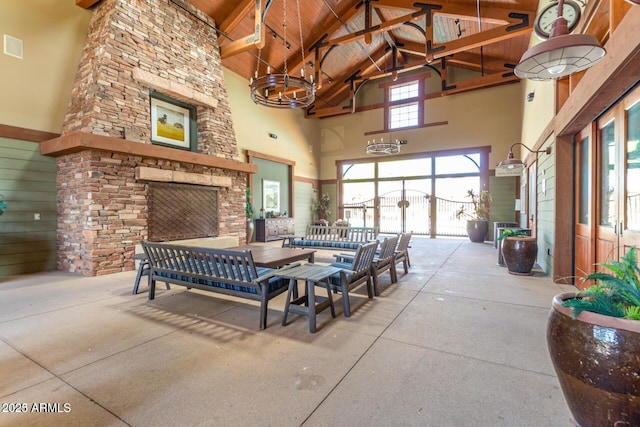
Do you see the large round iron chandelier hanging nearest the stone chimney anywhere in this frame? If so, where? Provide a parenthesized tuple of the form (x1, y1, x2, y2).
(249, 0, 316, 108)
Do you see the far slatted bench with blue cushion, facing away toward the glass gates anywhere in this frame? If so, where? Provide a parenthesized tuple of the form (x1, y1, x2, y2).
(283, 225, 378, 251)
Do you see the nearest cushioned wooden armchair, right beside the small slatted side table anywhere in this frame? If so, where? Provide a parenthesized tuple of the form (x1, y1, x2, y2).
(329, 240, 378, 317)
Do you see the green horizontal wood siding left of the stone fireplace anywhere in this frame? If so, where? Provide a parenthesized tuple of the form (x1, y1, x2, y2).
(0, 138, 57, 276)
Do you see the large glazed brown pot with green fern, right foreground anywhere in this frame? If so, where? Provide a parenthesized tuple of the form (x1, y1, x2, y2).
(547, 248, 640, 426)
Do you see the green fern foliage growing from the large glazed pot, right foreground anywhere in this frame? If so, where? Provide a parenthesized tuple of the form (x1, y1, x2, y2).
(562, 247, 640, 320)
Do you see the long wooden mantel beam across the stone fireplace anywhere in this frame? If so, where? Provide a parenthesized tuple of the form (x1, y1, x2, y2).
(40, 132, 258, 174)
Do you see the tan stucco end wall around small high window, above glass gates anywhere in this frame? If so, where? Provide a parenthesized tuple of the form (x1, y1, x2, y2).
(320, 84, 522, 179)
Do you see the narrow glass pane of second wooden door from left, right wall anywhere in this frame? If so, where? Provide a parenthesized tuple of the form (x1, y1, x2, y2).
(600, 122, 617, 227)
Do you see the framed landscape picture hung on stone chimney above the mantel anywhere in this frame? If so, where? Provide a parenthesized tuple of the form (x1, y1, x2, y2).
(151, 92, 197, 151)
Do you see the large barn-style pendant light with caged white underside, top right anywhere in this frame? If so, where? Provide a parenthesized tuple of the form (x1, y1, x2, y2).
(514, 0, 607, 80)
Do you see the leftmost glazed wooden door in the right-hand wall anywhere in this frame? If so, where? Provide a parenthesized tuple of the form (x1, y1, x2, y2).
(574, 125, 595, 287)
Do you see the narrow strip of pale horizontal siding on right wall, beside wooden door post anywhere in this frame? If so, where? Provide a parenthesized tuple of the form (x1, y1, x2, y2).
(537, 139, 556, 276)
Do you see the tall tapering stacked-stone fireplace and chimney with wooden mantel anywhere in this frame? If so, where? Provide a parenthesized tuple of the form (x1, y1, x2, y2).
(41, 0, 256, 275)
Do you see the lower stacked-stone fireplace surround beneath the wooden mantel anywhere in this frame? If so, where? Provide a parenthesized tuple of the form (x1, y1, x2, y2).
(57, 150, 246, 275)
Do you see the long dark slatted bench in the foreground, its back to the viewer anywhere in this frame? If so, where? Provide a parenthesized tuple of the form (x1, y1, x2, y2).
(142, 242, 298, 329)
